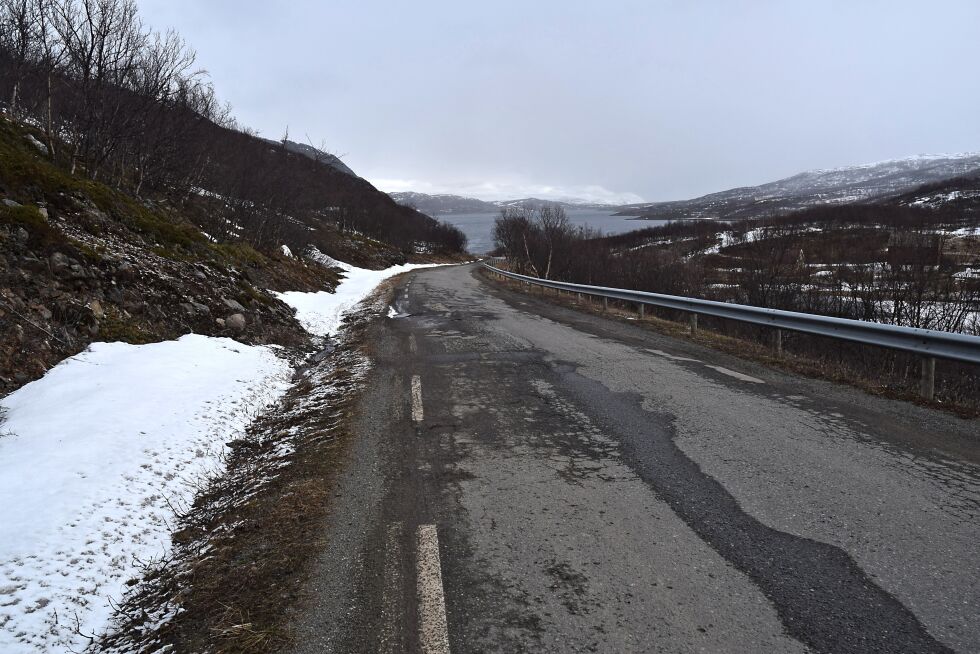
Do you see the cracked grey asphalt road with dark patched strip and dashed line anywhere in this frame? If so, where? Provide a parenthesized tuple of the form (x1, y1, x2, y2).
(296, 266, 980, 654)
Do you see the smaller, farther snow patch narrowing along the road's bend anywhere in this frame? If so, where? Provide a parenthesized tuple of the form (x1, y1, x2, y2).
(276, 262, 441, 336)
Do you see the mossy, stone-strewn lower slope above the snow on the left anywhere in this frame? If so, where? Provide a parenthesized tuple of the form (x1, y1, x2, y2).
(0, 117, 436, 394)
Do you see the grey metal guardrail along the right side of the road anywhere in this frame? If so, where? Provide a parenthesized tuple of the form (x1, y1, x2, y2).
(483, 262, 980, 398)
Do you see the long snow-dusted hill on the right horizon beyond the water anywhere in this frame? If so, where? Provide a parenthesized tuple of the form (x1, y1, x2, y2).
(619, 153, 980, 220)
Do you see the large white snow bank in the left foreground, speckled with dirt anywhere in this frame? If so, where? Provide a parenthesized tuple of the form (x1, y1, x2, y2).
(0, 334, 291, 654)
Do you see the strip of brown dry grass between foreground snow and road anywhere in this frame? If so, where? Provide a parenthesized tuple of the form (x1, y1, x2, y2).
(103, 296, 386, 654)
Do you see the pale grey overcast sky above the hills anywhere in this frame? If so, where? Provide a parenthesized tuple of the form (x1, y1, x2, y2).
(139, 0, 980, 201)
